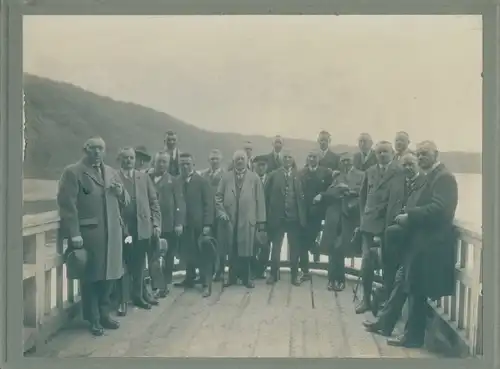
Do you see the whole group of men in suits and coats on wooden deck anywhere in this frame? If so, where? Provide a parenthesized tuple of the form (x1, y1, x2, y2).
(58, 131, 457, 347)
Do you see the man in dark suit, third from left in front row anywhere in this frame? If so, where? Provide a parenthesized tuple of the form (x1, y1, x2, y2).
(150, 152, 186, 298)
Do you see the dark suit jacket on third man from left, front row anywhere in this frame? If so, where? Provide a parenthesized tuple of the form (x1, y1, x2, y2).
(151, 173, 186, 233)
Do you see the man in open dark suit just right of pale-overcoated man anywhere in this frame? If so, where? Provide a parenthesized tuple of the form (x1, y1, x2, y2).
(265, 150, 309, 286)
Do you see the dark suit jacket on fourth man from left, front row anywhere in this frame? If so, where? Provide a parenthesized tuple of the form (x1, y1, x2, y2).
(184, 172, 215, 232)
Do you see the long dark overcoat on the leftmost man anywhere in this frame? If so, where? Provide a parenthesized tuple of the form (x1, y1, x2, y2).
(57, 160, 130, 282)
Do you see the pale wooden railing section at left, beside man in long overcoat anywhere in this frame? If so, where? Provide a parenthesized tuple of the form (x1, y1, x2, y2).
(23, 211, 80, 352)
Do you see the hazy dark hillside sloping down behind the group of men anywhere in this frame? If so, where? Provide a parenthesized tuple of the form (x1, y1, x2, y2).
(24, 75, 481, 179)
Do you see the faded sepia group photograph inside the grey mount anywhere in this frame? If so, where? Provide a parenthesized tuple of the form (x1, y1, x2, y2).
(23, 15, 483, 359)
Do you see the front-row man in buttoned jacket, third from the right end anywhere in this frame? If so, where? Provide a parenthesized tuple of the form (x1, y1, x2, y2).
(356, 141, 402, 314)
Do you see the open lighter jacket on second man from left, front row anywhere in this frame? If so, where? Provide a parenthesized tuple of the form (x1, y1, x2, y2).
(119, 170, 161, 240)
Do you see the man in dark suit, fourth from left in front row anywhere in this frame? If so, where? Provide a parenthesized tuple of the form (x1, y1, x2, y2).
(176, 153, 215, 295)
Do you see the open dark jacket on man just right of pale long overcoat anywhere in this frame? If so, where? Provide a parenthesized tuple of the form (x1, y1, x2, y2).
(264, 168, 307, 230)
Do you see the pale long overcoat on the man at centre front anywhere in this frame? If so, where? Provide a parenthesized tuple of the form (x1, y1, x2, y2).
(215, 170, 266, 257)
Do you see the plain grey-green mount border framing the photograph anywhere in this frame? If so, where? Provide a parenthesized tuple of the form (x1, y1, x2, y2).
(0, 0, 500, 369)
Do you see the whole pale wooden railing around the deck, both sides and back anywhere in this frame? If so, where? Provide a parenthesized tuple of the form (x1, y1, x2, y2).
(23, 211, 482, 356)
